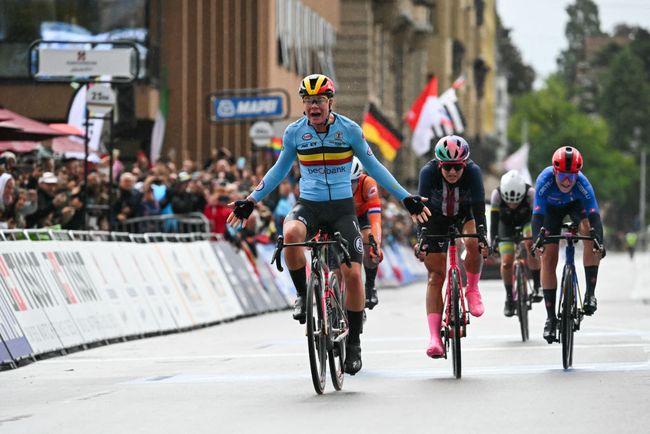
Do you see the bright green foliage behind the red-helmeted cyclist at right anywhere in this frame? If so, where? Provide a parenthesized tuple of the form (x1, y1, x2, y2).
(508, 76, 638, 225)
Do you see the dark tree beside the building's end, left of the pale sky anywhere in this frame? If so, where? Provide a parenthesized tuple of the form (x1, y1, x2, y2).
(497, 17, 535, 95)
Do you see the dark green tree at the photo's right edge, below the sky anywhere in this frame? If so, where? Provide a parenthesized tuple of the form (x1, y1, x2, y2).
(599, 45, 650, 151)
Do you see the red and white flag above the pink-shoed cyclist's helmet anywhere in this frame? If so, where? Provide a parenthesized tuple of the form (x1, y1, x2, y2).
(406, 77, 453, 155)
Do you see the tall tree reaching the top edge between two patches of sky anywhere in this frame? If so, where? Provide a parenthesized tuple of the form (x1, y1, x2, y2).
(557, 0, 603, 97)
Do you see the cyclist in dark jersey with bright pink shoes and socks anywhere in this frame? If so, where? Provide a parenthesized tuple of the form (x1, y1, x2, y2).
(418, 135, 487, 358)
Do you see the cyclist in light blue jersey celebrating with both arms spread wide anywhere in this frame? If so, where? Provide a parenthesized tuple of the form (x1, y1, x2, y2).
(228, 74, 429, 375)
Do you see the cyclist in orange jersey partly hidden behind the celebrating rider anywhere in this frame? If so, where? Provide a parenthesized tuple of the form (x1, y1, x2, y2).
(351, 157, 384, 310)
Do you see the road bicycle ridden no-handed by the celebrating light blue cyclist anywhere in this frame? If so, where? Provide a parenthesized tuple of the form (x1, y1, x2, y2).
(271, 228, 351, 395)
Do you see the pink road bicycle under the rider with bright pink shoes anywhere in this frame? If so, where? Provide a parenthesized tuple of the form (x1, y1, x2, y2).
(416, 225, 488, 378)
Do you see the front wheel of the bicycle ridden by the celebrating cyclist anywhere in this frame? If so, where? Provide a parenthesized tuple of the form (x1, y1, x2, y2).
(306, 273, 327, 395)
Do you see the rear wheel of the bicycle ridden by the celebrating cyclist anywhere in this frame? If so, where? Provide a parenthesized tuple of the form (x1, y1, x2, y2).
(327, 273, 348, 390)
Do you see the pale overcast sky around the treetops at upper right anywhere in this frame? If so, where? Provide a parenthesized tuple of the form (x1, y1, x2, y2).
(497, 0, 650, 87)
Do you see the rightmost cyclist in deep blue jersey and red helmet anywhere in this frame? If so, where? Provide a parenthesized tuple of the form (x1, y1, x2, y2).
(532, 146, 605, 344)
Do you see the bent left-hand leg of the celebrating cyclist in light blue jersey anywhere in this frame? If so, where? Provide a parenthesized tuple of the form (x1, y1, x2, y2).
(282, 202, 315, 324)
